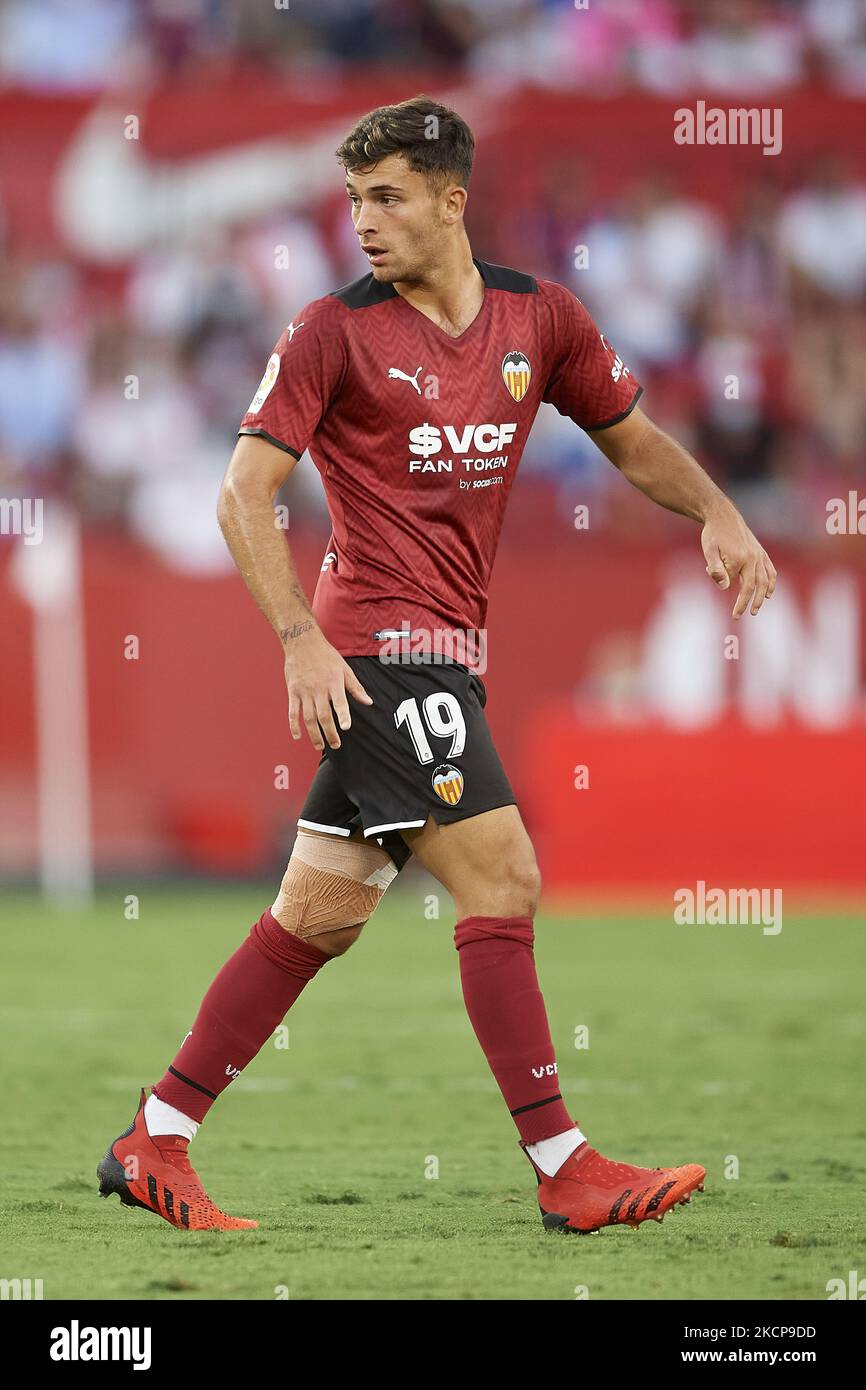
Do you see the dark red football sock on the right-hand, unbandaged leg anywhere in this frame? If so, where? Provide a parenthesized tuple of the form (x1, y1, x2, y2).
(455, 917, 575, 1144)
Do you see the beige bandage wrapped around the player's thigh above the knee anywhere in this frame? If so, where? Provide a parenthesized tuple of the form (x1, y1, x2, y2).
(271, 830, 398, 940)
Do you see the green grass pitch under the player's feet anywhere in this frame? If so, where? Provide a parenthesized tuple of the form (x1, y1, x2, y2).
(0, 872, 866, 1301)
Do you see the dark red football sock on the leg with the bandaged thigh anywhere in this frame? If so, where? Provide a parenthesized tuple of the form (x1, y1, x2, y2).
(153, 908, 331, 1122)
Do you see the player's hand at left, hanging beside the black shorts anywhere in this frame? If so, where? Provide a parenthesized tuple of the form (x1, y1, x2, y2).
(285, 627, 373, 752)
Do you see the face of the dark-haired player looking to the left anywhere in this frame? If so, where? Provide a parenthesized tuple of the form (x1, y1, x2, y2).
(346, 154, 448, 285)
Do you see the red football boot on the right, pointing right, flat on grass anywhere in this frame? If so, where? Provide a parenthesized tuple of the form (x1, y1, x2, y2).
(521, 1141, 706, 1234)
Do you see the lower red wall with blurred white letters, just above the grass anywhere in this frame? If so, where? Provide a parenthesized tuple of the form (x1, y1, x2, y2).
(0, 530, 866, 892)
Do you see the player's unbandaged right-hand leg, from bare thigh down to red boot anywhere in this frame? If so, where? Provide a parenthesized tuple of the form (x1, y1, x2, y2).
(403, 805, 706, 1233)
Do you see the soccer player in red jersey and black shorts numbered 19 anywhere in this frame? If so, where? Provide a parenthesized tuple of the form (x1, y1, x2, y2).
(99, 97, 776, 1232)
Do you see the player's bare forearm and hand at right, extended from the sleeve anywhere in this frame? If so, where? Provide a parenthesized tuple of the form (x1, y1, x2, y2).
(587, 406, 776, 617)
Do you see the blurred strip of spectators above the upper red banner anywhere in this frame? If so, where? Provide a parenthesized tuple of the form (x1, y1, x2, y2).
(0, 0, 866, 95)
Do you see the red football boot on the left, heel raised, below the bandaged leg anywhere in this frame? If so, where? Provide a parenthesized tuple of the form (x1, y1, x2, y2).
(96, 1087, 259, 1230)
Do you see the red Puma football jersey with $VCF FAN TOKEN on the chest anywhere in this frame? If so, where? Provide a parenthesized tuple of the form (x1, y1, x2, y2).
(239, 260, 642, 664)
